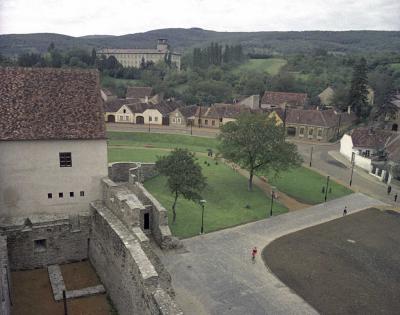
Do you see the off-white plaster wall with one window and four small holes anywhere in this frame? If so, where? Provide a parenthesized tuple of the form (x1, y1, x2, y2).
(0, 140, 107, 216)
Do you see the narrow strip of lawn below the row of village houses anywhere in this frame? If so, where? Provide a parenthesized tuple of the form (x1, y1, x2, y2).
(107, 132, 218, 152)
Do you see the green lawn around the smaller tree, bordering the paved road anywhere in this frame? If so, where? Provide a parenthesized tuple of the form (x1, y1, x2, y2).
(144, 157, 287, 238)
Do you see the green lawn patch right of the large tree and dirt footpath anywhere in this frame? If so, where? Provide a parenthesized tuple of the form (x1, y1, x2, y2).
(267, 167, 352, 204)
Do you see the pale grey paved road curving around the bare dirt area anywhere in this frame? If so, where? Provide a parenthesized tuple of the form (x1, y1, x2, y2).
(160, 193, 382, 315)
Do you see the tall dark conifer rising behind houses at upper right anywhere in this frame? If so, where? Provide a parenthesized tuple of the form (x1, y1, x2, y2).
(348, 58, 369, 118)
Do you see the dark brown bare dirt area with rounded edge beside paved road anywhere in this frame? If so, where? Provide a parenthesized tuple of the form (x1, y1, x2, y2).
(262, 209, 400, 314)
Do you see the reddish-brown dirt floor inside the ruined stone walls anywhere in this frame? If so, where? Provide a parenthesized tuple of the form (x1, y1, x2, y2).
(11, 261, 111, 315)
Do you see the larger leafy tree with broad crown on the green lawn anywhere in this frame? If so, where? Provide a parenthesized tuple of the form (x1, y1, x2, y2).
(219, 113, 302, 191)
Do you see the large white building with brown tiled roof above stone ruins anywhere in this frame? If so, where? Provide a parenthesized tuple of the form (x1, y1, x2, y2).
(0, 68, 107, 216)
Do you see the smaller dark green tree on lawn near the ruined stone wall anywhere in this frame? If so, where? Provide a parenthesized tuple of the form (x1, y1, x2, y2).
(156, 148, 206, 223)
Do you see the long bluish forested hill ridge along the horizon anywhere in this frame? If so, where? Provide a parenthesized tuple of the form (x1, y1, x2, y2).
(0, 28, 400, 56)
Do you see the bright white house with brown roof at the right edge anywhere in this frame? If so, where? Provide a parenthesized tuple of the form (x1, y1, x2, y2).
(340, 127, 400, 184)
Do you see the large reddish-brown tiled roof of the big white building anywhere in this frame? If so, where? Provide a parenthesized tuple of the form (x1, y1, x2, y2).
(0, 67, 106, 140)
